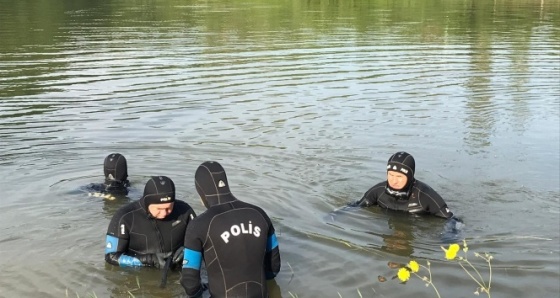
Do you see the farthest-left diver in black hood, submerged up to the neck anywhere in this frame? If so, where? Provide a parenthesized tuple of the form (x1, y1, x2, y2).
(86, 153, 130, 196)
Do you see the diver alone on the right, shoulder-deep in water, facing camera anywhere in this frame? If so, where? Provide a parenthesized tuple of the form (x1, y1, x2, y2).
(352, 152, 453, 218)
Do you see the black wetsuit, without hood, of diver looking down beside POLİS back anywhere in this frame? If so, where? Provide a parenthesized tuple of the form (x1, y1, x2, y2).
(105, 198, 196, 267)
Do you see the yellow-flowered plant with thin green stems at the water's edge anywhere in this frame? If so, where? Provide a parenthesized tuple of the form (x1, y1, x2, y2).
(379, 240, 494, 298)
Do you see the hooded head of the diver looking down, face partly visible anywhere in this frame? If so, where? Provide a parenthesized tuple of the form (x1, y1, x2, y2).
(140, 176, 175, 219)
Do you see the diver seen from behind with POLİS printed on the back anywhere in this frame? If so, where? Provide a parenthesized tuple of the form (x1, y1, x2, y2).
(181, 161, 280, 298)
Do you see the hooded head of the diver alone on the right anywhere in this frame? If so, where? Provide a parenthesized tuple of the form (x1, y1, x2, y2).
(387, 151, 416, 197)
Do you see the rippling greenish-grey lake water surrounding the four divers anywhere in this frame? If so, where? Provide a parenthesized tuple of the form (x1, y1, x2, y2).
(0, 0, 560, 298)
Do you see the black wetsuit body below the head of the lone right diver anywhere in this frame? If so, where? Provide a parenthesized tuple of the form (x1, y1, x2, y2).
(356, 180, 453, 218)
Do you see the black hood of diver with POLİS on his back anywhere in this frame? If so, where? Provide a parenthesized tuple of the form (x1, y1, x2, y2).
(194, 161, 235, 208)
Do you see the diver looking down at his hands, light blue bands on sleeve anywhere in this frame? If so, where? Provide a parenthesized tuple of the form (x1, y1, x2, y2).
(105, 176, 196, 268)
